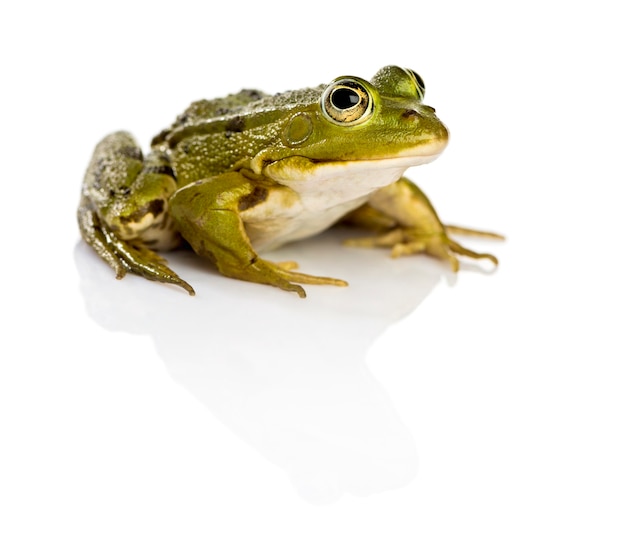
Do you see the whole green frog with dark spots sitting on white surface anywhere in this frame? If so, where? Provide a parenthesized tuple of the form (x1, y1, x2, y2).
(77, 65, 502, 297)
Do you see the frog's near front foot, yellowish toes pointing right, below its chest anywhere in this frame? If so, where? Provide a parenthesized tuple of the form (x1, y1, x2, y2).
(217, 257, 348, 298)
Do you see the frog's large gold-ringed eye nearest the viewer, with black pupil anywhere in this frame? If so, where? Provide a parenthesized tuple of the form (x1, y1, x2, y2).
(321, 79, 373, 125)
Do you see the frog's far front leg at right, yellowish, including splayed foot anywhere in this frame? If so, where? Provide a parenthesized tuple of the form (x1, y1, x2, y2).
(346, 177, 503, 272)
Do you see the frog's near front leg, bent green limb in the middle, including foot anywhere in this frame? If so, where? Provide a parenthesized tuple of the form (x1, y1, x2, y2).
(170, 170, 346, 298)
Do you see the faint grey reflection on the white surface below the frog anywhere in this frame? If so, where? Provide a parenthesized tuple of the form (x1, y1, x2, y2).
(75, 230, 445, 504)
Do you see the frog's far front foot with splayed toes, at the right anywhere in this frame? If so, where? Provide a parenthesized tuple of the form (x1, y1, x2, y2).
(345, 226, 503, 272)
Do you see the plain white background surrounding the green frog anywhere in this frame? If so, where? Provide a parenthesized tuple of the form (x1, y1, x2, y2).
(0, 0, 626, 536)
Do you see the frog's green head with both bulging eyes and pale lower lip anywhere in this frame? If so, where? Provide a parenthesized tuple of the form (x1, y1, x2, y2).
(252, 66, 448, 184)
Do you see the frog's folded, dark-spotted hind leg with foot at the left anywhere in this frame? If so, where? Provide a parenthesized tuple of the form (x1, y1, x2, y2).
(77, 132, 194, 295)
